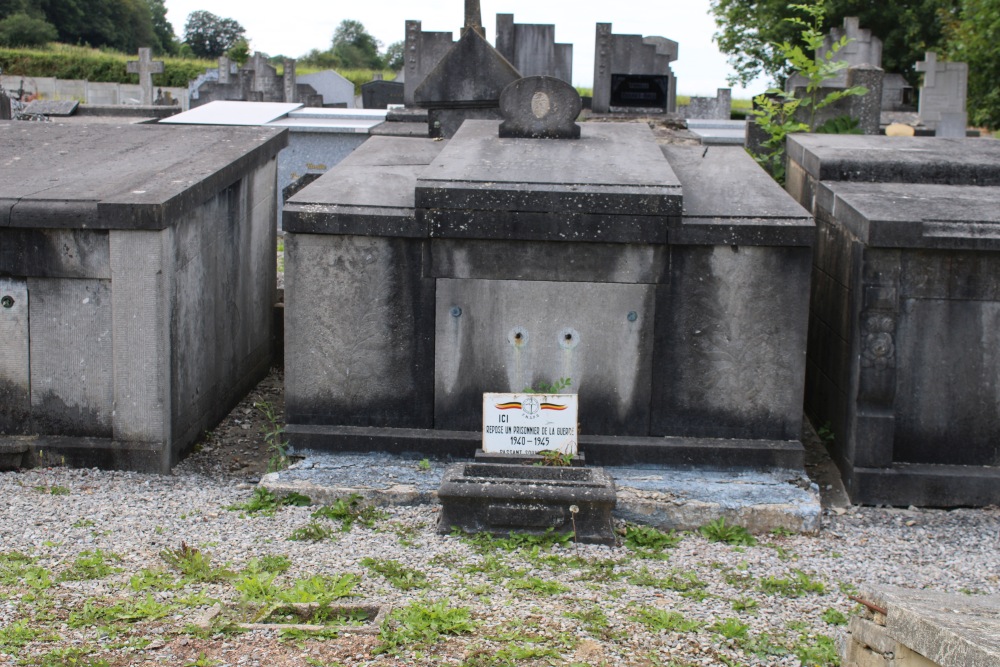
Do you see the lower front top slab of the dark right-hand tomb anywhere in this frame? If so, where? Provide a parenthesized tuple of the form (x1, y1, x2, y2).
(816, 182, 1000, 250)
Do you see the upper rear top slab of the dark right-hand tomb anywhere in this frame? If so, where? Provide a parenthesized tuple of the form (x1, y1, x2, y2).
(788, 134, 1000, 185)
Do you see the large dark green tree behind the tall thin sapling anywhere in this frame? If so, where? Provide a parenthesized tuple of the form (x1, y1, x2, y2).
(711, 0, 961, 84)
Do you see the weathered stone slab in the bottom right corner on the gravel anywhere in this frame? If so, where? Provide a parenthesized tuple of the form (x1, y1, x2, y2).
(862, 587, 1000, 667)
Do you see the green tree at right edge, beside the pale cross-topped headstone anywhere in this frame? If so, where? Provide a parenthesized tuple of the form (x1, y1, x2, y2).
(945, 0, 1000, 130)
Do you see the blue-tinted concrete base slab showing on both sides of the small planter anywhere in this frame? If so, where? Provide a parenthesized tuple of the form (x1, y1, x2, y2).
(260, 451, 821, 533)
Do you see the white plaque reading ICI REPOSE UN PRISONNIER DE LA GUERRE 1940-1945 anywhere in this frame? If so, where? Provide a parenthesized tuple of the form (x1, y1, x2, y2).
(483, 394, 579, 454)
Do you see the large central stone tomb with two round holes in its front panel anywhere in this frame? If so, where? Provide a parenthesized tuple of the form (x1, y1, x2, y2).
(283, 120, 814, 468)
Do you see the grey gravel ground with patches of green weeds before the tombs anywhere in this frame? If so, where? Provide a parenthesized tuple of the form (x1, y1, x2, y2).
(0, 371, 1000, 667)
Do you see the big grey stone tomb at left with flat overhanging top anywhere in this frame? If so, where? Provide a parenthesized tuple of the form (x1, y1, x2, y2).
(0, 123, 287, 473)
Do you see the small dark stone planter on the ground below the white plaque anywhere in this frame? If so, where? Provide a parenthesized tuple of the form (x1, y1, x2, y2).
(438, 463, 616, 545)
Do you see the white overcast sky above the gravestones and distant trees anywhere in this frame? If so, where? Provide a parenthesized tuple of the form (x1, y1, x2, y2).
(166, 0, 767, 97)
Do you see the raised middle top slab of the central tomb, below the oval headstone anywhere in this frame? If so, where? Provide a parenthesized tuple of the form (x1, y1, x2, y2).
(416, 121, 681, 223)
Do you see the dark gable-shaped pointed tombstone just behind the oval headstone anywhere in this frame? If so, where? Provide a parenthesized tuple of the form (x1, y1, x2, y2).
(413, 21, 521, 137)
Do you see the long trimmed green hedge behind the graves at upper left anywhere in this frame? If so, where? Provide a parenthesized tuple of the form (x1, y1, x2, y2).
(0, 49, 215, 88)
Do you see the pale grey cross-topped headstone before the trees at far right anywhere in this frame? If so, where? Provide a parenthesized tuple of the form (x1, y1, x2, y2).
(916, 51, 969, 137)
